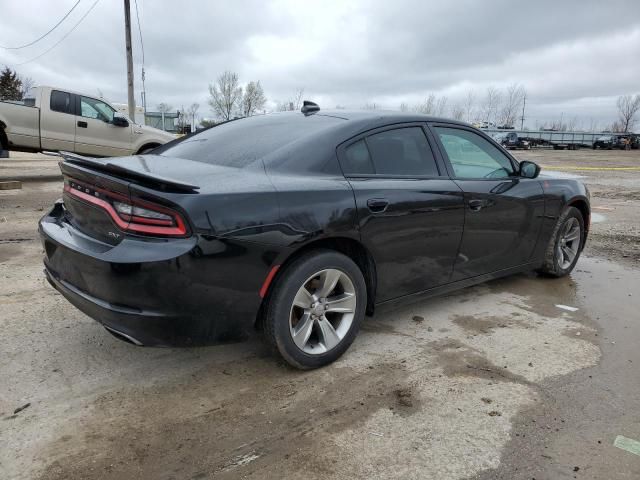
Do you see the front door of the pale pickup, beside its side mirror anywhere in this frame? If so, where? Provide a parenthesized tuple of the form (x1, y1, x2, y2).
(74, 95, 133, 156)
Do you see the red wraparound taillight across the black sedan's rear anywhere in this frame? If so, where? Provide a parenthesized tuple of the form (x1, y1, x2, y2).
(64, 180, 187, 237)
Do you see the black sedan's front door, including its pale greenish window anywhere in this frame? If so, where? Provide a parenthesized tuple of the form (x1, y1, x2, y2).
(431, 124, 544, 281)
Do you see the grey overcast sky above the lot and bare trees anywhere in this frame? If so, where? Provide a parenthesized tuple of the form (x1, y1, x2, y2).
(0, 0, 640, 127)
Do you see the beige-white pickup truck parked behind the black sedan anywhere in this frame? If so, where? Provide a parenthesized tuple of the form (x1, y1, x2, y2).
(0, 87, 175, 157)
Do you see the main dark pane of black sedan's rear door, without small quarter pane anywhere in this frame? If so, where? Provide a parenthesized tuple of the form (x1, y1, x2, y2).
(367, 127, 438, 176)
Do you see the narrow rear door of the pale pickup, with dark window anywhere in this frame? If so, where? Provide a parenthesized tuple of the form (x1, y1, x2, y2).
(40, 90, 76, 151)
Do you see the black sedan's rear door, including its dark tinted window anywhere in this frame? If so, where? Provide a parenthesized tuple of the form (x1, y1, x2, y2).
(338, 123, 464, 301)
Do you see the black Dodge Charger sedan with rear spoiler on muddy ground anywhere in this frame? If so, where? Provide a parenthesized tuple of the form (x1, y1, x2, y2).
(40, 102, 590, 368)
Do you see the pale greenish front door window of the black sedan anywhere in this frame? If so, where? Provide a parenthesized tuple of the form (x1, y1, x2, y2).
(435, 127, 513, 178)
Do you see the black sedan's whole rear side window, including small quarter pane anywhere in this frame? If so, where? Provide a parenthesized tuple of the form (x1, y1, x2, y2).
(343, 127, 439, 177)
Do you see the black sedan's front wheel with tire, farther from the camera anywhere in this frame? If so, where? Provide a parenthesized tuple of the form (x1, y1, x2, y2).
(538, 207, 584, 278)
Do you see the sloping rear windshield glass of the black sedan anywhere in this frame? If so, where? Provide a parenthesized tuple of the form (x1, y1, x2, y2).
(160, 113, 343, 168)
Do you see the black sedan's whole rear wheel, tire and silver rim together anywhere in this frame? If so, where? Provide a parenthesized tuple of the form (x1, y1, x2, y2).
(264, 250, 367, 370)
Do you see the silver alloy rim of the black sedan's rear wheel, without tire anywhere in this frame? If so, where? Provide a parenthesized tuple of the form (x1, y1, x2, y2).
(289, 268, 357, 355)
